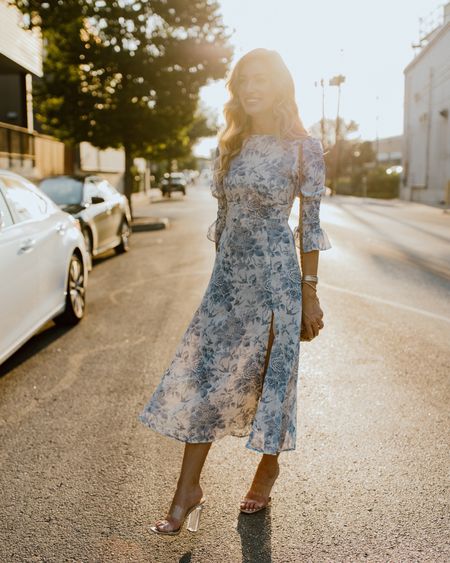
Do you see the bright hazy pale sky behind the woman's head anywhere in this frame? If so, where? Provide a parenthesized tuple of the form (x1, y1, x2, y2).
(194, 0, 445, 156)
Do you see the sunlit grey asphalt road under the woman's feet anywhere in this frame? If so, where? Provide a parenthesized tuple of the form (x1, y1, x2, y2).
(0, 187, 450, 563)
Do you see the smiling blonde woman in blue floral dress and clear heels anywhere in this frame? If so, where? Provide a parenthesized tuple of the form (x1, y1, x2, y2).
(139, 49, 331, 534)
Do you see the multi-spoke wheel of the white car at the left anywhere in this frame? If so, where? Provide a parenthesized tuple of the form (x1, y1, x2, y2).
(53, 252, 86, 325)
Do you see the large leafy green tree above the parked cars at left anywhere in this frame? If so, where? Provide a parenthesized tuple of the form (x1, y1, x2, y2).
(12, 0, 232, 218)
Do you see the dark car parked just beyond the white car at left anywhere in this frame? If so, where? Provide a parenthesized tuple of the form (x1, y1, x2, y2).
(39, 175, 131, 264)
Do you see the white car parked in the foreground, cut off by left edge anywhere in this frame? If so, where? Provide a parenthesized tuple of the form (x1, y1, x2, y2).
(0, 169, 89, 364)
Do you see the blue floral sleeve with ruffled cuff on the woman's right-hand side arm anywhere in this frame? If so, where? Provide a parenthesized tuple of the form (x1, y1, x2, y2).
(294, 137, 331, 252)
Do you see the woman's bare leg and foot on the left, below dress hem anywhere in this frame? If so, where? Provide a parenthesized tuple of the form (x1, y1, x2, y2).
(155, 442, 211, 532)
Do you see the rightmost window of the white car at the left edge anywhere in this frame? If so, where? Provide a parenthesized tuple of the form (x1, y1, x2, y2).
(1, 176, 49, 221)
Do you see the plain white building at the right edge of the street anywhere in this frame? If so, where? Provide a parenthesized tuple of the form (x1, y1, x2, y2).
(400, 2, 450, 206)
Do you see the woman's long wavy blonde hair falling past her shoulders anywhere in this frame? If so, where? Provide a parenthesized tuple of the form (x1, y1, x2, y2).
(214, 48, 309, 183)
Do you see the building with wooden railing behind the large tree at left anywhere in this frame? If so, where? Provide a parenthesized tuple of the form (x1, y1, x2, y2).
(0, 0, 150, 192)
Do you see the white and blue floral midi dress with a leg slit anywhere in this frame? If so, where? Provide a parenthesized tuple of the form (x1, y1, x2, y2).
(139, 135, 331, 454)
